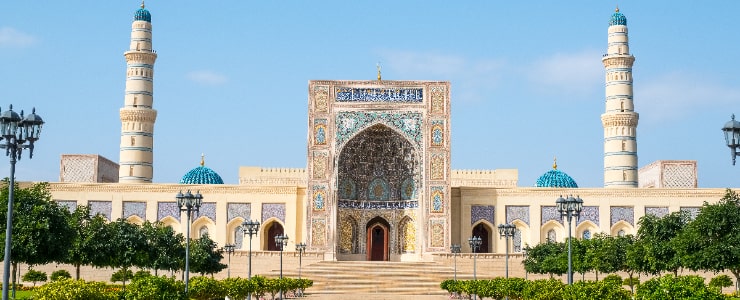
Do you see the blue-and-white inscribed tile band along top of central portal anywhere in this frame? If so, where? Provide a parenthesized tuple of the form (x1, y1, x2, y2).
(336, 87, 424, 103)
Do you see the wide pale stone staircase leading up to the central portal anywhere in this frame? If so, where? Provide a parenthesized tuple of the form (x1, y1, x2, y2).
(270, 261, 460, 296)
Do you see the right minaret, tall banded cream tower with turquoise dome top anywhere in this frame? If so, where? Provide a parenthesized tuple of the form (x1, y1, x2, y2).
(601, 8, 639, 187)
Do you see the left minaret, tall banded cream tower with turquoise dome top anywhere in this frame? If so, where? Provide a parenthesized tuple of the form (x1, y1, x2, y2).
(118, 1, 157, 183)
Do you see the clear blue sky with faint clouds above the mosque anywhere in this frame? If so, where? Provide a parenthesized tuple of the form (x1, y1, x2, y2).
(0, 0, 740, 187)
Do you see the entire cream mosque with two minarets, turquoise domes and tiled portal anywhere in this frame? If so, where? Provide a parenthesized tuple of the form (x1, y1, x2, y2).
(50, 4, 724, 261)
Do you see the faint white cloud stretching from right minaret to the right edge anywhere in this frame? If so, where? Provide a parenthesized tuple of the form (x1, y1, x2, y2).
(635, 72, 740, 121)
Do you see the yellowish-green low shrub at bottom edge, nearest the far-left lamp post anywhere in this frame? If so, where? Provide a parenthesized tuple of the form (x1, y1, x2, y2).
(33, 279, 118, 300)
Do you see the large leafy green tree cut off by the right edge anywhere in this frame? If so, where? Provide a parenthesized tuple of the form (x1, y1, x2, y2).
(675, 189, 740, 292)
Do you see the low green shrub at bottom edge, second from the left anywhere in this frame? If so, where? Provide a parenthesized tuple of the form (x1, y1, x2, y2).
(125, 276, 187, 300)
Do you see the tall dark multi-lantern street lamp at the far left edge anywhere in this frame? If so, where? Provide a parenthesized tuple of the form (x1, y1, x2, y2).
(0, 105, 44, 300)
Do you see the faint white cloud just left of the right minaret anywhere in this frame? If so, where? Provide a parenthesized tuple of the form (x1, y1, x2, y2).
(524, 50, 604, 95)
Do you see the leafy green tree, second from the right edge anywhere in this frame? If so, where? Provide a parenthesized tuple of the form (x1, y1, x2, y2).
(637, 211, 690, 276)
